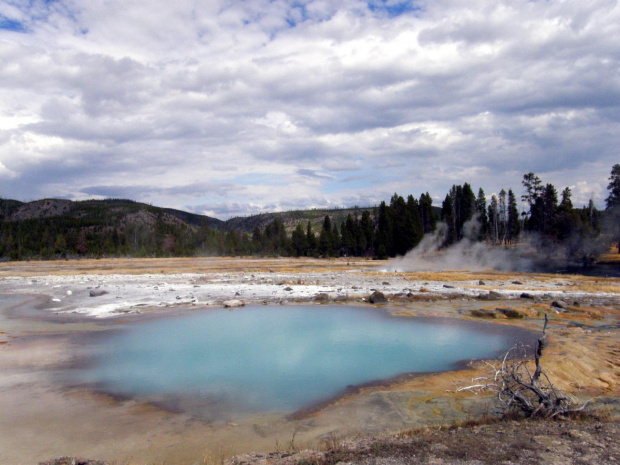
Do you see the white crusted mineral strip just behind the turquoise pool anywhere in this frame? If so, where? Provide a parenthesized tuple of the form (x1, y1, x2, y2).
(0, 260, 620, 318)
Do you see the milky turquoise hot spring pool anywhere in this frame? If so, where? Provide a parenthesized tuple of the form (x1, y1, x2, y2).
(70, 306, 528, 416)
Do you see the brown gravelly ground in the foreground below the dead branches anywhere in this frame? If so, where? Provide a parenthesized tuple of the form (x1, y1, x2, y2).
(224, 419, 620, 465)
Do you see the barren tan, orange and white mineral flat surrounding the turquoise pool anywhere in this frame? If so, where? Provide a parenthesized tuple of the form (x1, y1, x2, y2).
(0, 258, 620, 464)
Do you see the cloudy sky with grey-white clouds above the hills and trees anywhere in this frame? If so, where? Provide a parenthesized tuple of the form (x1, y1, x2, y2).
(0, 0, 620, 219)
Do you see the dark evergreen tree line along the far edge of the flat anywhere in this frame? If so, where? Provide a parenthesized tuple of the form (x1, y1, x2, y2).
(0, 164, 620, 262)
